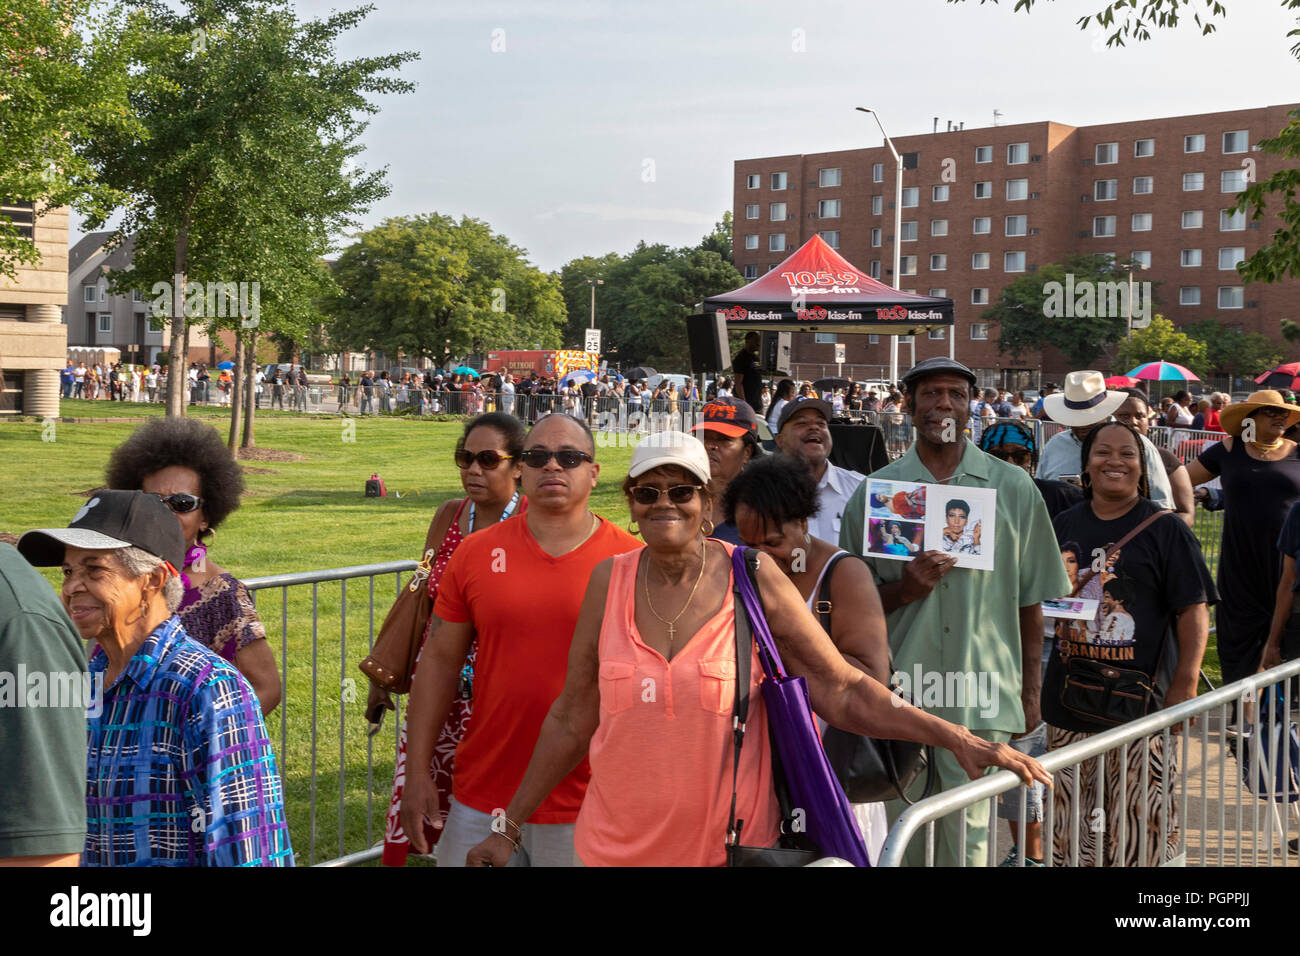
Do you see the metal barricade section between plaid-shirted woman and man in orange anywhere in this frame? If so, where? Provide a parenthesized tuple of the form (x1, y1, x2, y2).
(244, 561, 416, 865)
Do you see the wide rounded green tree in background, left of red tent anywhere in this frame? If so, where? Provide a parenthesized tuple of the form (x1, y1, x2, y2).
(325, 213, 564, 364)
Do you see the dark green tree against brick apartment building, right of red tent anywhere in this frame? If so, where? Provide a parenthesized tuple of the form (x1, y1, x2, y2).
(982, 255, 1154, 368)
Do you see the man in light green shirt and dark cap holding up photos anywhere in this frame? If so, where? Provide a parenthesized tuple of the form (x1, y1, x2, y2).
(840, 358, 1070, 866)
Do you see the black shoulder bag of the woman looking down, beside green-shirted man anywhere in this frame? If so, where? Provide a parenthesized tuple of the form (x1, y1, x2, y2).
(814, 551, 936, 804)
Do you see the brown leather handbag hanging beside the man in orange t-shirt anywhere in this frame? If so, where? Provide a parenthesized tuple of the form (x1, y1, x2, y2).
(358, 519, 450, 724)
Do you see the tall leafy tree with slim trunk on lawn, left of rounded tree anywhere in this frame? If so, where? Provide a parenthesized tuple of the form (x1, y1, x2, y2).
(82, 0, 415, 415)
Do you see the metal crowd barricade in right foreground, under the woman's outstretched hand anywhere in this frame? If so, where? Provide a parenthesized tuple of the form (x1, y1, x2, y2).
(879, 659, 1300, 866)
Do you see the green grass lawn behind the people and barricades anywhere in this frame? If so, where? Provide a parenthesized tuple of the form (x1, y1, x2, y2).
(0, 401, 1219, 865)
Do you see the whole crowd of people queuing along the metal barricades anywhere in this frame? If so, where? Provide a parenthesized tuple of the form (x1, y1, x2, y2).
(12, 359, 1300, 866)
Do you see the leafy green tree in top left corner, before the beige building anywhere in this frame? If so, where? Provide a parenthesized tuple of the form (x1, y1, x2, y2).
(0, 0, 142, 278)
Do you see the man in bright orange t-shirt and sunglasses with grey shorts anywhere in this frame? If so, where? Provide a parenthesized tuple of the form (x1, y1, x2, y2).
(402, 414, 641, 866)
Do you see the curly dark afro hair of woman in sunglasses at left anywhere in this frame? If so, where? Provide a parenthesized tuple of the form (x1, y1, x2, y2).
(105, 418, 244, 533)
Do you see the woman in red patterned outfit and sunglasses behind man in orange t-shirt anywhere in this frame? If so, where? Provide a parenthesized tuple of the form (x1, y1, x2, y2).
(384, 412, 528, 866)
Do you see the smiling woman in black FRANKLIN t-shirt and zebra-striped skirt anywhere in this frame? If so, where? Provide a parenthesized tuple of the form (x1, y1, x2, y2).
(1043, 421, 1218, 866)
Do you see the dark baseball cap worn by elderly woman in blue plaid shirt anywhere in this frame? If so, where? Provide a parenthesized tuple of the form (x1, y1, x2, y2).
(18, 489, 185, 571)
